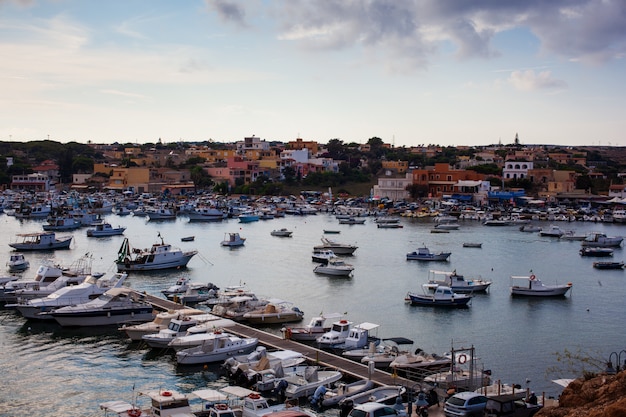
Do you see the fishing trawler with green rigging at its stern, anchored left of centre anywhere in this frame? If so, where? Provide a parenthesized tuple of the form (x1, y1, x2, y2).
(115, 233, 198, 272)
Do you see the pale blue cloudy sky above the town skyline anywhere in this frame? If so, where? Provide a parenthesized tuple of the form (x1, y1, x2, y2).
(0, 0, 626, 146)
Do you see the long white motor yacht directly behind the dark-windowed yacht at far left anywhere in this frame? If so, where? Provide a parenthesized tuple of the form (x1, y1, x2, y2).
(15, 273, 128, 320)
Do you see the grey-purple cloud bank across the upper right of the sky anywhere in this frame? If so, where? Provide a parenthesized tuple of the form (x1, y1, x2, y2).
(271, 0, 626, 66)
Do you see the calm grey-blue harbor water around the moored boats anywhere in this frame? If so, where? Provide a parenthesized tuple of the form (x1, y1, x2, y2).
(0, 213, 626, 417)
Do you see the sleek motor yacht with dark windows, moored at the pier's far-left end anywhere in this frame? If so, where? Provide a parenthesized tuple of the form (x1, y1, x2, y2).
(48, 287, 154, 327)
